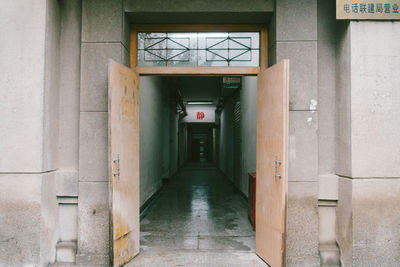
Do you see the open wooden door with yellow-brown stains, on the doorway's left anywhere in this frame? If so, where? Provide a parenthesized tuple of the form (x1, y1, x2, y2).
(108, 60, 140, 266)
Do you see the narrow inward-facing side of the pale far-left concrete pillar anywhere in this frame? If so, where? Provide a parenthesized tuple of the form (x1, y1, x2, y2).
(40, 1, 61, 265)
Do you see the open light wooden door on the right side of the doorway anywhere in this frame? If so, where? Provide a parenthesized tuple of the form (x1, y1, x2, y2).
(256, 60, 289, 267)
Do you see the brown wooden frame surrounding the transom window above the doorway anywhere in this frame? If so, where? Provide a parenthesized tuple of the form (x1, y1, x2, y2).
(112, 24, 288, 265)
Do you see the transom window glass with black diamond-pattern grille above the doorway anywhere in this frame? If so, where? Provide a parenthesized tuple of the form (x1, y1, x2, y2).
(137, 32, 260, 67)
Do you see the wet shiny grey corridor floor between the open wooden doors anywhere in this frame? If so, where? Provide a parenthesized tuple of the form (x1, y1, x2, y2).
(127, 163, 267, 267)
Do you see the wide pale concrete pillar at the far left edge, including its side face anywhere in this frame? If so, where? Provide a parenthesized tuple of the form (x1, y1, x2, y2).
(0, 1, 80, 266)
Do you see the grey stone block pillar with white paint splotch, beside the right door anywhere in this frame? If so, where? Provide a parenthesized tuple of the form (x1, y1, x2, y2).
(268, 0, 320, 266)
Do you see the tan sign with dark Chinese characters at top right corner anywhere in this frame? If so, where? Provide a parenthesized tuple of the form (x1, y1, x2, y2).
(336, 0, 400, 20)
